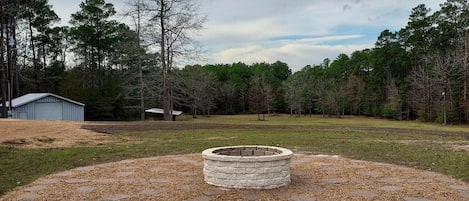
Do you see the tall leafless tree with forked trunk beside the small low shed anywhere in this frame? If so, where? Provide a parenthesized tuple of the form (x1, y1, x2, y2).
(142, 0, 206, 120)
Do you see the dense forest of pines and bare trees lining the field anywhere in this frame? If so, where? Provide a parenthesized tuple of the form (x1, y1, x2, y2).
(0, 0, 469, 124)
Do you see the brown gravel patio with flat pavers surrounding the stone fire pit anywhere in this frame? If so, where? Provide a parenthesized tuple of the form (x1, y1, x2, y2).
(0, 154, 469, 201)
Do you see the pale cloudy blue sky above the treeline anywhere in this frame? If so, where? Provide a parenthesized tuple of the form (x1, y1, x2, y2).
(49, 0, 445, 72)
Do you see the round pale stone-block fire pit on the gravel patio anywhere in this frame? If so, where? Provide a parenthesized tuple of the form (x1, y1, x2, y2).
(202, 146, 293, 189)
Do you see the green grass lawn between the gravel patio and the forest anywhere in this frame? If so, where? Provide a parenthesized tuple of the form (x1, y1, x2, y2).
(0, 115, 469, 195)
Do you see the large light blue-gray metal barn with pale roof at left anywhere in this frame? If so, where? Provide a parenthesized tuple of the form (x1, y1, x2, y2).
(7, 93, 85, 121)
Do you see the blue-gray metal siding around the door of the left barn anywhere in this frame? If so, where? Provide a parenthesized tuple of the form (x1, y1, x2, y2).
(12, 96, 85, 121)
